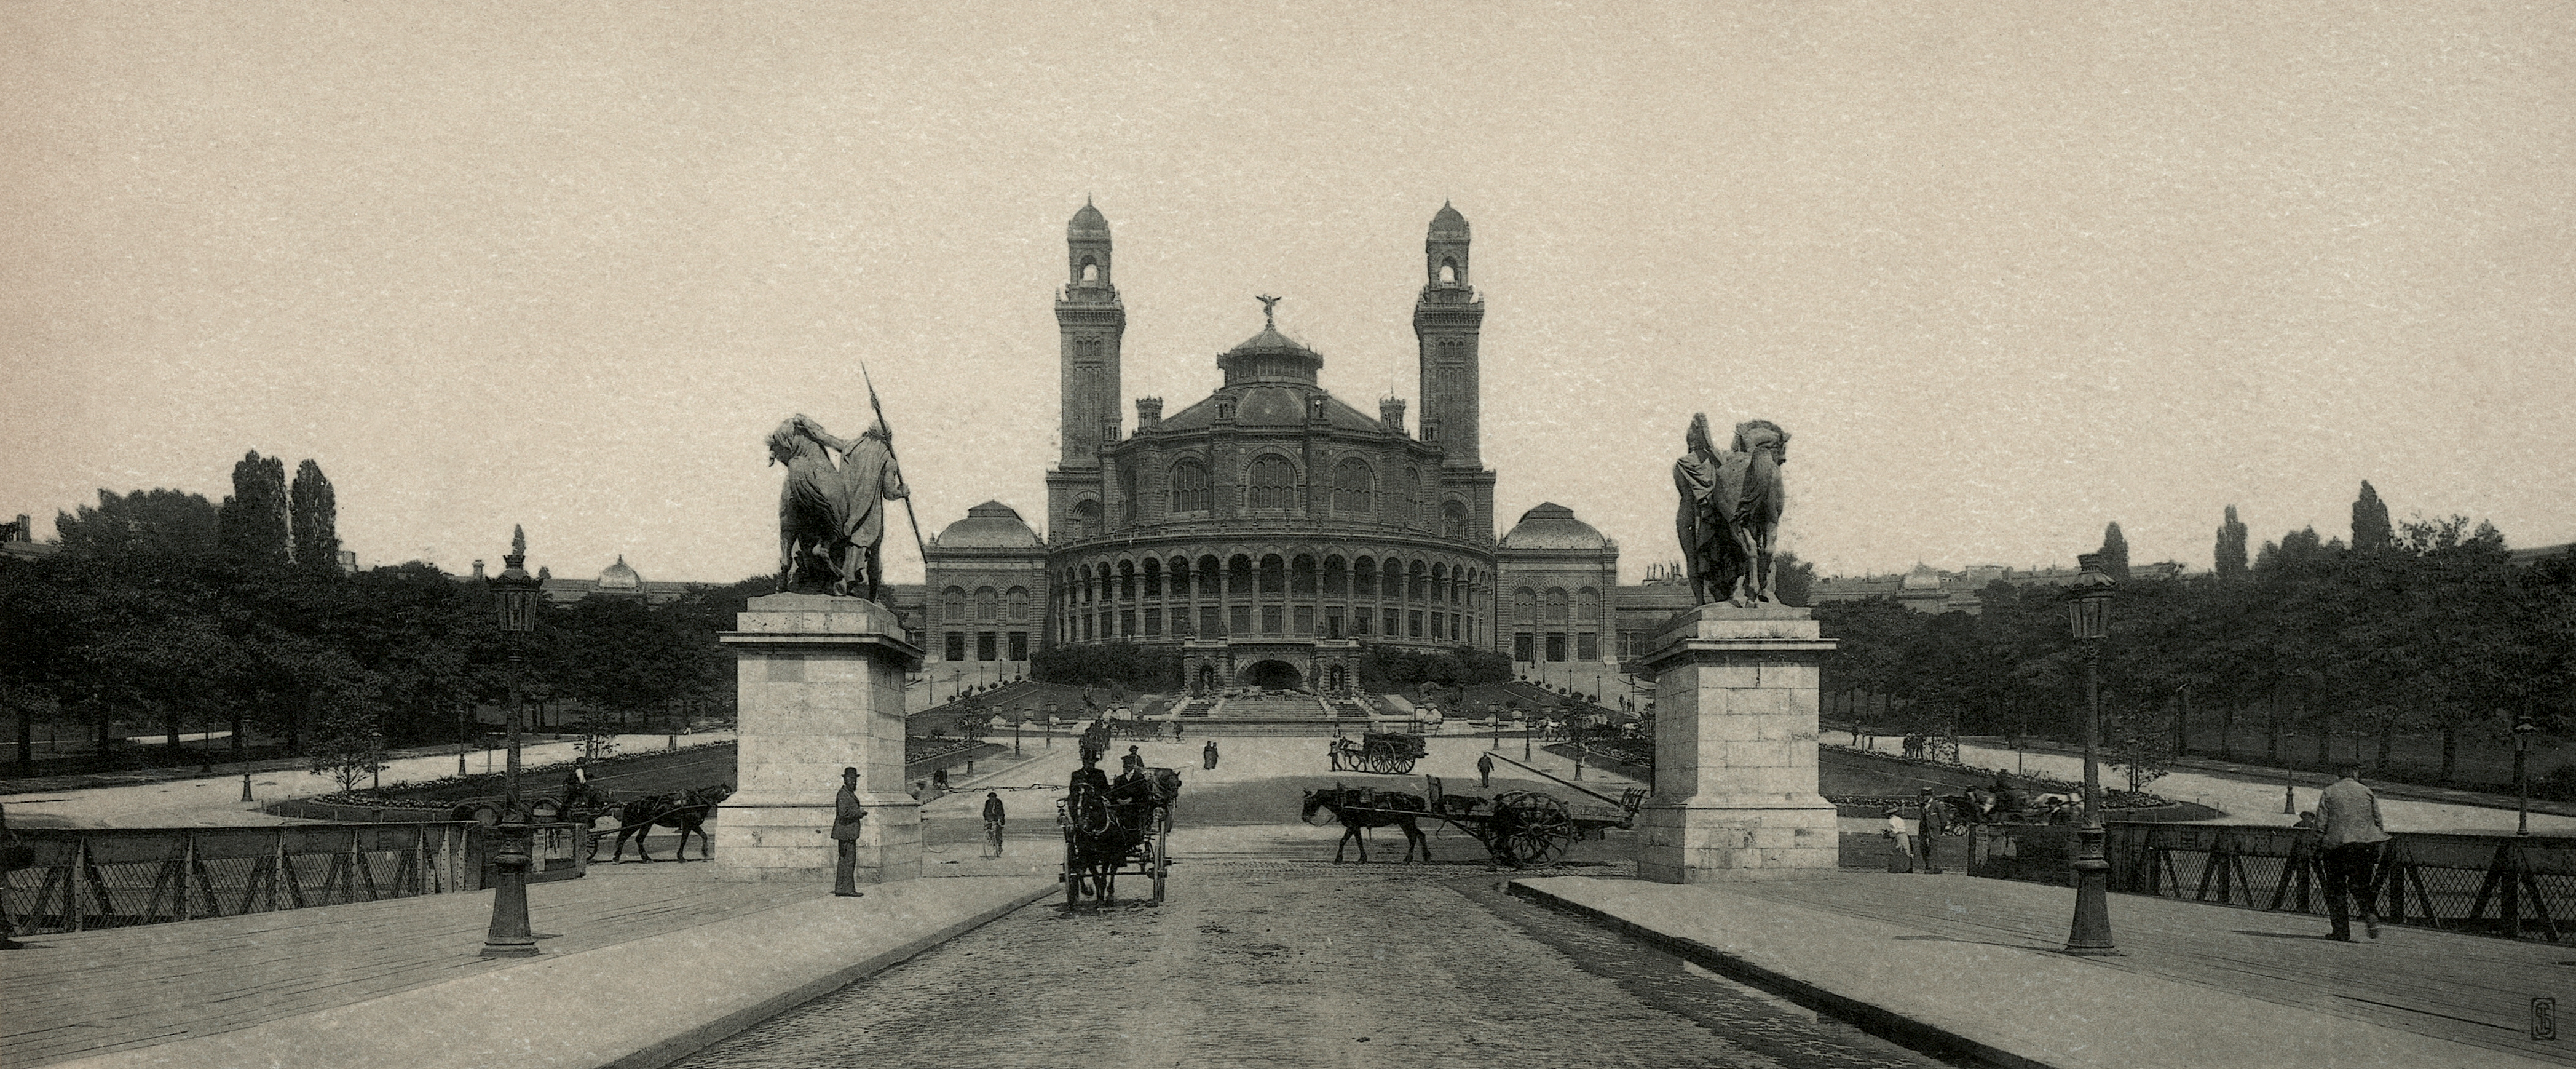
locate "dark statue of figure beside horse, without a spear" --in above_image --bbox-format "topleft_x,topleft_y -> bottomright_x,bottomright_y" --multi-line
1672,412 -> 1788,608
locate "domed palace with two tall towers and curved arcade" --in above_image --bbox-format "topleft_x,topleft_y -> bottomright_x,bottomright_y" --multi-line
922,204 -> 1618,690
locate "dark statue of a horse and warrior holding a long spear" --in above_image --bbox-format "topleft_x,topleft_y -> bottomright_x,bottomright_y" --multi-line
770,415 -> 909,600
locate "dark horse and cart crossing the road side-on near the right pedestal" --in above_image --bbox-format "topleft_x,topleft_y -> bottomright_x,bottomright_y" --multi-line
1301,776 -> 1646,868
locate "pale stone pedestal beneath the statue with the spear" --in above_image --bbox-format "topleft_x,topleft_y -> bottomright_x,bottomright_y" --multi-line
716,595 -> 922,886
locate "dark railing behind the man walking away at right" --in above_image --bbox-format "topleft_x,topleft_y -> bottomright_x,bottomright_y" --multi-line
1968,822 -> 2576,943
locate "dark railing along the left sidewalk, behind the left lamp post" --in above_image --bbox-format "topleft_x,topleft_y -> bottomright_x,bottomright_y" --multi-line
0,822 -> 585,935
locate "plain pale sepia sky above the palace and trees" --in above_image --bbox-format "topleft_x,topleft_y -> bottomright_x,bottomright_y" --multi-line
0,0 -> 2576,579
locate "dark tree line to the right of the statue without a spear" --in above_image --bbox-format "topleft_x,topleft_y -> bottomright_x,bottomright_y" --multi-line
1816,482 -> 2576,783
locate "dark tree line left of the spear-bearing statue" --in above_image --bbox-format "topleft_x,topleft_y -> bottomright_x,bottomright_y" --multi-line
0,453 -> 770,768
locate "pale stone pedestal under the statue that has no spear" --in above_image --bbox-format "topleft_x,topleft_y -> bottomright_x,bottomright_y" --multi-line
1636,603 -> 1842,883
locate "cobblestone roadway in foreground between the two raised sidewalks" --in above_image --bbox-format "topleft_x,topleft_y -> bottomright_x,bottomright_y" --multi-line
685,860 -> 1937,1069
